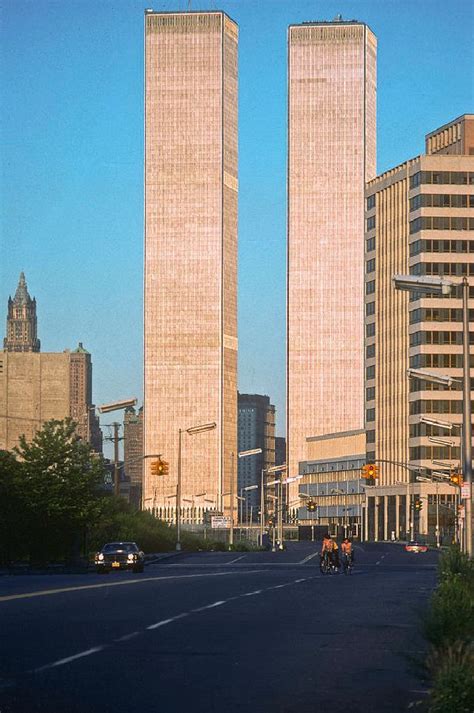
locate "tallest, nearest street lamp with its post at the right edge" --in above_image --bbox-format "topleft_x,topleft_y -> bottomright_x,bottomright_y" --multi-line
393,275 -> 472,557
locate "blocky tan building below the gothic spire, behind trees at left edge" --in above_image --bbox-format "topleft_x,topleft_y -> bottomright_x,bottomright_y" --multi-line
0,344 -> 102,452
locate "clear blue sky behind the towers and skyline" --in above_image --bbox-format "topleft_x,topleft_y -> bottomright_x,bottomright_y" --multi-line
0,0 -> 474,435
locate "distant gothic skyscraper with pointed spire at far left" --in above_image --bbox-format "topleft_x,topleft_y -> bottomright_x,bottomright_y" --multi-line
3,272 -> 40,352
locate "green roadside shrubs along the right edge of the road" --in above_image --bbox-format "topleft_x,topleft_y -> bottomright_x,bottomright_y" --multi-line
423,547 -> 474,713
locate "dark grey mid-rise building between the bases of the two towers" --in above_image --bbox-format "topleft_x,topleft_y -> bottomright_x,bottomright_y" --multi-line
238,394 -> 275,522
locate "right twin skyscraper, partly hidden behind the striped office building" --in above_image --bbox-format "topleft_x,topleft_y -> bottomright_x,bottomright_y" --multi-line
287,20 -> 377,499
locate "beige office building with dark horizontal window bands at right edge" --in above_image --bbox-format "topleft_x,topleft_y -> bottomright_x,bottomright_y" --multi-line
365,115 -> 474,539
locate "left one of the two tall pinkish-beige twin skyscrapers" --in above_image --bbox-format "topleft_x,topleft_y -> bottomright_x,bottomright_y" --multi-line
144,11 -> 238,519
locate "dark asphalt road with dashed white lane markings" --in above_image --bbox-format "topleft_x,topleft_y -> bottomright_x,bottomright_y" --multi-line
0,543 -> 437,713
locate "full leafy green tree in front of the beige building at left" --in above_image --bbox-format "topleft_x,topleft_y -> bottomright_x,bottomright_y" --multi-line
15,419 -> 105,561
